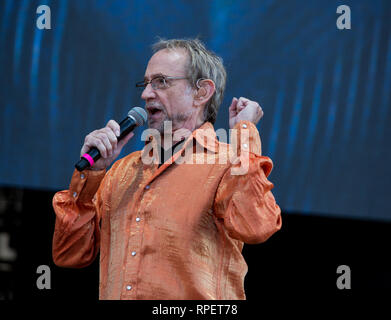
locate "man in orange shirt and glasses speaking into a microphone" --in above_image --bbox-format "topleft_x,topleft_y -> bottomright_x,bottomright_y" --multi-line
53,40 -> 281,299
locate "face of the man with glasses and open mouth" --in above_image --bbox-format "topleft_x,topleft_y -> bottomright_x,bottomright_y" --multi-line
141,49 -> 195,133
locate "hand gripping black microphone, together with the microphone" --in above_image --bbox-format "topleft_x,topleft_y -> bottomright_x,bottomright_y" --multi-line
75,107 -> 147,171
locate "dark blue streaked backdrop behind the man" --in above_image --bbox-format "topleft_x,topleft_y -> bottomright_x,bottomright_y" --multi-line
0,0 -> 391,220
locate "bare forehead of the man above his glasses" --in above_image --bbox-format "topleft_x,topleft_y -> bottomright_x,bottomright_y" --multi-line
145,49 -> 187,78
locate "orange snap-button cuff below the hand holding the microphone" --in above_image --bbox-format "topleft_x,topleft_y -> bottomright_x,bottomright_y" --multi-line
69,169 -> 106,201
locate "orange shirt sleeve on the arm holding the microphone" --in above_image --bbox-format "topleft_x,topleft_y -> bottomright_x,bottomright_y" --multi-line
52,170 -> 106,268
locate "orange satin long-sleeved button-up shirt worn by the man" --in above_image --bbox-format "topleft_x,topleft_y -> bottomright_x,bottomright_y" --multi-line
53,121 -> 281,300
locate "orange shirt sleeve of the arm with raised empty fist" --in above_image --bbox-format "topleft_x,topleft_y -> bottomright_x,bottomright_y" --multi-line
214,121 -> 282,244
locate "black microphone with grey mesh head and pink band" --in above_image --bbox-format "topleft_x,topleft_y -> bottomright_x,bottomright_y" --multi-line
75,107 -> 148,171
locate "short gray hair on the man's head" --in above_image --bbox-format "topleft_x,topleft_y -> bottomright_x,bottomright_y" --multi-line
152,39 -> 227,124
